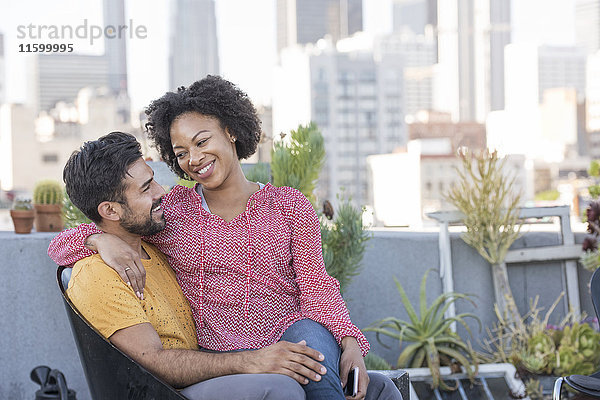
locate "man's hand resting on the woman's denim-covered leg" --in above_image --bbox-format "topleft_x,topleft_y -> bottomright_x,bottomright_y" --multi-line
246,340 -> 327,384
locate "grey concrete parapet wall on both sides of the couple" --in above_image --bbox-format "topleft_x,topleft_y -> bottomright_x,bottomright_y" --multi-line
0,231 -> 594,400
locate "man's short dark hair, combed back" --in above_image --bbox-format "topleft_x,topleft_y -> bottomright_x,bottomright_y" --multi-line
63,132 -> 142,223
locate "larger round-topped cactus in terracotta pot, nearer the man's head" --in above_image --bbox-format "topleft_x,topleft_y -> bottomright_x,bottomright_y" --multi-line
33,180 -> 64,232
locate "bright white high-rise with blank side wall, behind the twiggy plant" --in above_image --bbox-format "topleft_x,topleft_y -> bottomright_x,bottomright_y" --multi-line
486,43 -> 586,162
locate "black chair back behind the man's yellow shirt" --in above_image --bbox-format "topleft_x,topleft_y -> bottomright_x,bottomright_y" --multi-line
56,267 -> 186,400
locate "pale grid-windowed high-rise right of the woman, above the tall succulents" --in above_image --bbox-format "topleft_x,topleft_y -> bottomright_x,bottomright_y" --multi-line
310,38 -> 406,204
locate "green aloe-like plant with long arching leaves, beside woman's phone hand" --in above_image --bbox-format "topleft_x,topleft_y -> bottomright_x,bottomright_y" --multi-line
365,270 -> 481,390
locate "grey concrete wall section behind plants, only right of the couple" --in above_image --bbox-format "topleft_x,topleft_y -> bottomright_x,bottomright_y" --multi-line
344,231 -> 595,365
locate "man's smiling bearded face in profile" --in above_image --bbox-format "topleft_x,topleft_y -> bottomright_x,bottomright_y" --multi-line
121,158 -> 166,236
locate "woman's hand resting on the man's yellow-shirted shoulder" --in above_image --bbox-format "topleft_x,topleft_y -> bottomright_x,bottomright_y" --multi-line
85,233 -> 146,300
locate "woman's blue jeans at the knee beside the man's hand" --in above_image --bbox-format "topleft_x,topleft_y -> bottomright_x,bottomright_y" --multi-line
279,319 -> 345,400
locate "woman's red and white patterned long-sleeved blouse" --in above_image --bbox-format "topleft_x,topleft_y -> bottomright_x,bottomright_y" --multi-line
48,184 -> 369,355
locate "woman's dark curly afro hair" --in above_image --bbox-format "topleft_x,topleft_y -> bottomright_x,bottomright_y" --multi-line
146,75 -> 261,178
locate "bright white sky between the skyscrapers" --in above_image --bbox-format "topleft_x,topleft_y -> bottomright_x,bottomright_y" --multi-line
0,0 -> 575,110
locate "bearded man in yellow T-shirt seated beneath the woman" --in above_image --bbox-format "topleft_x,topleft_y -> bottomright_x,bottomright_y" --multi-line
63,132 -> 323,399
